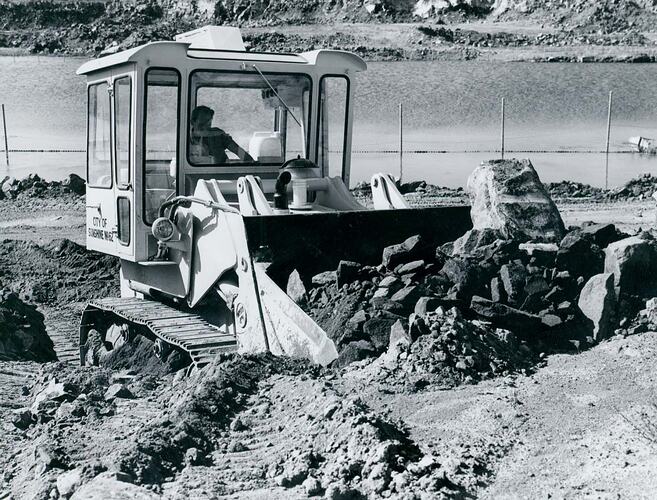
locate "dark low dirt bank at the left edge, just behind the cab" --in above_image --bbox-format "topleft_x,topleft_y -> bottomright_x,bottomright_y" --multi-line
0,239 -> 119,305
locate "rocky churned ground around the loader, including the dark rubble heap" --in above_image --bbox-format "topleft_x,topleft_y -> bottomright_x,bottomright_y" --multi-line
5,170 -> 657,499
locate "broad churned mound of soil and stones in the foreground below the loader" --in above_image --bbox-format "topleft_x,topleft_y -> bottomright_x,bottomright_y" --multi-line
8,355 -> 476,498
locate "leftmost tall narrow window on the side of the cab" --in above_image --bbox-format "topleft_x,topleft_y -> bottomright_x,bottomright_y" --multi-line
87,82 -> 112,188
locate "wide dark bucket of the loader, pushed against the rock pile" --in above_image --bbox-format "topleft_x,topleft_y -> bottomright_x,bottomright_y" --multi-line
244,206 -> 472,289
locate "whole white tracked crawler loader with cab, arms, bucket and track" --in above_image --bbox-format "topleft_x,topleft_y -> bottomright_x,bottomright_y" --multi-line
78,26 -> 470,367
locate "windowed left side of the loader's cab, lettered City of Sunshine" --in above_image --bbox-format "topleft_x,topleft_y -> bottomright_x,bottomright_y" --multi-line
87,75 -> 134,259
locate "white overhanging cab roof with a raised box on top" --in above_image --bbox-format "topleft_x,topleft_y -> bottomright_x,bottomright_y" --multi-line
77,26 -> 367,75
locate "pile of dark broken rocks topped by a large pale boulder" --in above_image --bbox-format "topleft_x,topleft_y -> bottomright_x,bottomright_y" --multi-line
307,161 -> 657,381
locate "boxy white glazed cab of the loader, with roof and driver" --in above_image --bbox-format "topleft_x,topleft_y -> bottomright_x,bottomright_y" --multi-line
78,26 -> 366,262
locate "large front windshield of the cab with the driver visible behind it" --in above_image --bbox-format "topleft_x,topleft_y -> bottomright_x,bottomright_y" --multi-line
187,68 -> 311,166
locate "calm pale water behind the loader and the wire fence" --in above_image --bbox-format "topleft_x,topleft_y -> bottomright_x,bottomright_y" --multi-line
0,56 -> 657,186
